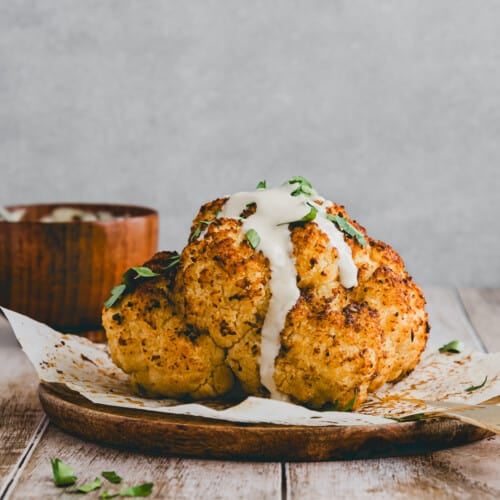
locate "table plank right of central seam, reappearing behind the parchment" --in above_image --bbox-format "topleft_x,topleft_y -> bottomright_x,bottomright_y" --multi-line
286,287 -> 500,500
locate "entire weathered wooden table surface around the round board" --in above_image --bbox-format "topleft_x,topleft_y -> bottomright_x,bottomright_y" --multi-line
0,287 -> 500,500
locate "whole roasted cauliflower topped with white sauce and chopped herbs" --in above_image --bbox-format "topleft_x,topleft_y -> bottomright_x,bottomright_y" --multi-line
103,177 -> 429,410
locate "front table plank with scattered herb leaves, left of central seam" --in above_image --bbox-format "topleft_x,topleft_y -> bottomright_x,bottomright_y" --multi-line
10,425 -> 281,500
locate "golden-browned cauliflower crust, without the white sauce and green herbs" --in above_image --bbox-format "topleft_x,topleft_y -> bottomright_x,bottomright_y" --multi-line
103,191 -> 429,409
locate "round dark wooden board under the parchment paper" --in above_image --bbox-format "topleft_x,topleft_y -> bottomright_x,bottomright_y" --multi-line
39,385 -> 491,461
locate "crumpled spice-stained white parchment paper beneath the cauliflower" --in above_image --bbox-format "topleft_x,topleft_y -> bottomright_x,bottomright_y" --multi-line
0,308 -> 500,433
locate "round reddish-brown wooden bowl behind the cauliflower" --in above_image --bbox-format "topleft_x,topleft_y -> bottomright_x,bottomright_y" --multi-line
0,203 -> 158,332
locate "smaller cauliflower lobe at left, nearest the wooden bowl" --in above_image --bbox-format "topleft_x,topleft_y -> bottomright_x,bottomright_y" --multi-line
103,252 -> 234,399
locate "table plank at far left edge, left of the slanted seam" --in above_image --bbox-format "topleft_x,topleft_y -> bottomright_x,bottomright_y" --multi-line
0,314 -> 46,498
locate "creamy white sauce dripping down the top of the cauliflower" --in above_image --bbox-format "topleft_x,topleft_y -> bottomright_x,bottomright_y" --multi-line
219,183 -> 357,400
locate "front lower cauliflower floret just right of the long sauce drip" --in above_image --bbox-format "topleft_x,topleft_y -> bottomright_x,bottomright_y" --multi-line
275,297 -> 383,409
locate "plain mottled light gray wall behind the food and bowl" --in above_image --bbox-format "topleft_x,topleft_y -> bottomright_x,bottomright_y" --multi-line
0,0 -> 500,286
